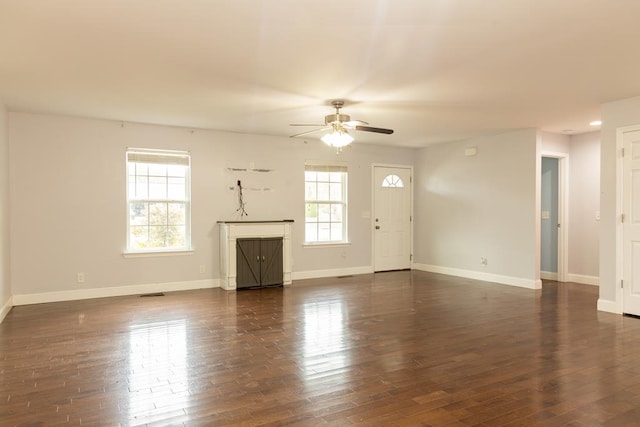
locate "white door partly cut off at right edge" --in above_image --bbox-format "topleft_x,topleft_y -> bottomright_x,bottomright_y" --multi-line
622,131 -> 640,315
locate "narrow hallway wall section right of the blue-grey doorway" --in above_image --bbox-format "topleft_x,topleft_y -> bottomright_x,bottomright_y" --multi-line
568,131 -> 600,283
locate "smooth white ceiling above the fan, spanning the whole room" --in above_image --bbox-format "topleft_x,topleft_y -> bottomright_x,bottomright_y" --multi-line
0,0 -> 640,146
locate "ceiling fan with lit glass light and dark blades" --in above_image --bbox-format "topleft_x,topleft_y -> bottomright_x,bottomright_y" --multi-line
291,100 -> 393,151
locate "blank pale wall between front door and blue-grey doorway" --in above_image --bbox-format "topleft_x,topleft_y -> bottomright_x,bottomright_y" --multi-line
414,129 -> 539,287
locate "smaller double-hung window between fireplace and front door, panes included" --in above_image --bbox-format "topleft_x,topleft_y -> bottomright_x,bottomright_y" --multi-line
304,162 -> 348,243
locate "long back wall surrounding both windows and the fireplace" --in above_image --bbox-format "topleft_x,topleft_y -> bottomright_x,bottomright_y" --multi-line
9,113 -> 415,304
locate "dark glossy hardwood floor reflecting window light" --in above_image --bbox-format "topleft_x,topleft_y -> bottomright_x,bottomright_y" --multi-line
0,271 -> 640,426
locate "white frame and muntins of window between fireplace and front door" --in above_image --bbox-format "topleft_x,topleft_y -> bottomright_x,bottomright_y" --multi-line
304,161 -> 349,246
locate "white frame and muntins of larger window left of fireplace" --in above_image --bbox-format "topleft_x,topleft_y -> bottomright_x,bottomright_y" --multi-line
125,148 -> 192,254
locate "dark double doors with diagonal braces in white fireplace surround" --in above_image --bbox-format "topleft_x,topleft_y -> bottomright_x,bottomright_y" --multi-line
236,237 -> 284,289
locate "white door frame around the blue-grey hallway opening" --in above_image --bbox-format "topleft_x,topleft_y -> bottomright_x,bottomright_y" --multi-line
536,151 -> 569,282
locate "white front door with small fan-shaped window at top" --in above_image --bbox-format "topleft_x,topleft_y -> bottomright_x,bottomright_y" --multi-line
373,166 -> 412,271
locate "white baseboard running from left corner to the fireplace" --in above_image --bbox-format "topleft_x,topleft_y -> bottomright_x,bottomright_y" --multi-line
13,279 -> 220,305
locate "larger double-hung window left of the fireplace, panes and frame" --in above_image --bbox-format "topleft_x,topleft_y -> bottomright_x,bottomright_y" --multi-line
127,149 -> 191,252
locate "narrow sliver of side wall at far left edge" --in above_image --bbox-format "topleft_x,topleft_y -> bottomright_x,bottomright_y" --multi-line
0,102 -> 11,321
